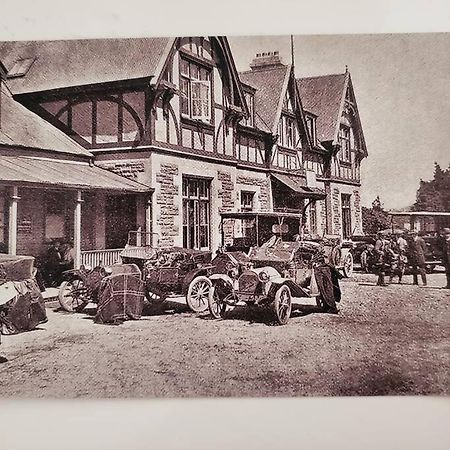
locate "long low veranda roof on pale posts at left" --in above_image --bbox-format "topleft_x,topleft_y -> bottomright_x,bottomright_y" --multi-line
0,156 -> 152,193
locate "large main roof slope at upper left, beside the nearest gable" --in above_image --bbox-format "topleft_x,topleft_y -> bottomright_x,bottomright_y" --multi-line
0,38 -> 174,95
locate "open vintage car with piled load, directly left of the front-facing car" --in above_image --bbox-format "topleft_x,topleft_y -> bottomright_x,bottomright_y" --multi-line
121,231 -> 213,312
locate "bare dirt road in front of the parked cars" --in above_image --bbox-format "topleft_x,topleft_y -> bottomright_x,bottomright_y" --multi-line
0,274 -> 450,398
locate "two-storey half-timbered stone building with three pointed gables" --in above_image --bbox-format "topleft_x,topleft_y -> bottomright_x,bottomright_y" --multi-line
0,36 -> 365,264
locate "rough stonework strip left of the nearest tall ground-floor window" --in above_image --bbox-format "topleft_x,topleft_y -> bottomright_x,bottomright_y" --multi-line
155,164 -> 181,246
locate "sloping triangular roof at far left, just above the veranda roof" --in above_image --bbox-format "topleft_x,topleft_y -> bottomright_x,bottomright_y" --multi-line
0,83 -> 92,157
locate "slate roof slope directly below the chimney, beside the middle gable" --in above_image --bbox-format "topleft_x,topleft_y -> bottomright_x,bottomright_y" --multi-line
239,65 -> 291,133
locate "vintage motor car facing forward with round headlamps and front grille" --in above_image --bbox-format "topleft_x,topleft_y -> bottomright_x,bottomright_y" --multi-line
208,217 -> 340,325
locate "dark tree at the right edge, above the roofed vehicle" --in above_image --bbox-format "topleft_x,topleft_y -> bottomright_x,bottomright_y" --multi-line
413,163 -> 450,211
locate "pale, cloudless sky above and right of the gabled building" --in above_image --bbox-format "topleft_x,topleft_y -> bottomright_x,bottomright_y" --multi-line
229,33 -> 450,209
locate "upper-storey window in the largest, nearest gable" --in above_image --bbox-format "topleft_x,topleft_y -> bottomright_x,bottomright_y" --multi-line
180,58 -> 211,122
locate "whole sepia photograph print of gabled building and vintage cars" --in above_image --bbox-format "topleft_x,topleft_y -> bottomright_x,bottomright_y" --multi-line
0,29 -> 450,399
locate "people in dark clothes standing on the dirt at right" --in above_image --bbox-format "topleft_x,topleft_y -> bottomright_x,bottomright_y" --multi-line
368,228 -> 450,289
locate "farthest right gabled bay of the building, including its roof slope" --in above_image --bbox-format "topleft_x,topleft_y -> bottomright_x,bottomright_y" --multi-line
297,70 -> 367,238
